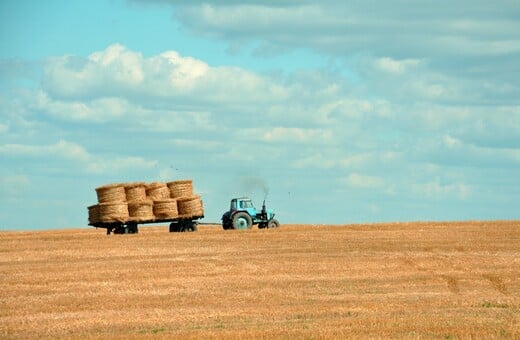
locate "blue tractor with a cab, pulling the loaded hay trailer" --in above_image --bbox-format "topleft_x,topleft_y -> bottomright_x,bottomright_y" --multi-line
222,197 -> 280,230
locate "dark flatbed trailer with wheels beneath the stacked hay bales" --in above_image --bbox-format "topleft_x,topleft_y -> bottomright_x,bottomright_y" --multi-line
89,215 -> 204,235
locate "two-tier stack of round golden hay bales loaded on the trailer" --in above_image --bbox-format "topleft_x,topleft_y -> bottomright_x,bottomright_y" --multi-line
88,180 -> 204,225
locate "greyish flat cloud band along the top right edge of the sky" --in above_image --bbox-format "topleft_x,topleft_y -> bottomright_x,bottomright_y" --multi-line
168,0 -> 520,63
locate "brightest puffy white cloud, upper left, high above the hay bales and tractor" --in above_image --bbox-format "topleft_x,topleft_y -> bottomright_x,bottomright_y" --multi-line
43,45 -> 286,106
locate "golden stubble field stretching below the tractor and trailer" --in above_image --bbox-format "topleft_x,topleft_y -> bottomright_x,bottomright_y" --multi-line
0,221 -> 520,339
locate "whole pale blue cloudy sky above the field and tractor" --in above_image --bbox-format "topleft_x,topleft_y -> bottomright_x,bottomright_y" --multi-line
0,0 -> 520,230
